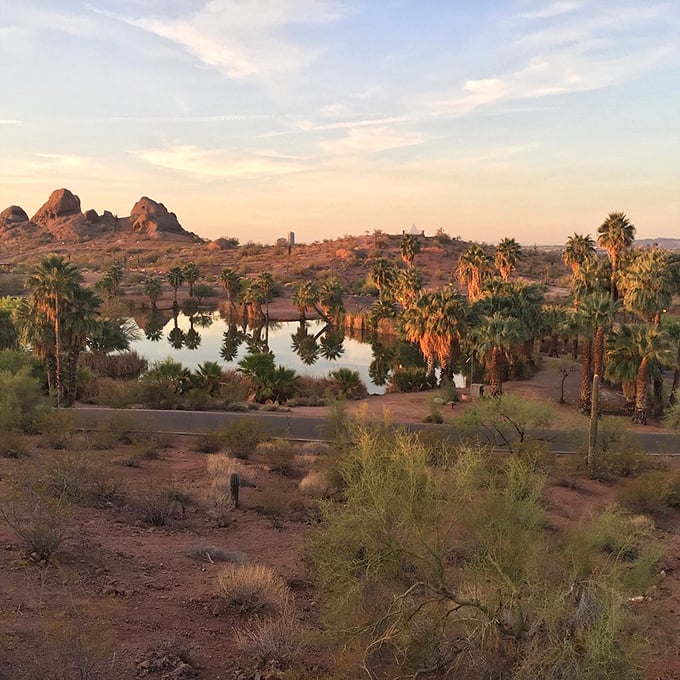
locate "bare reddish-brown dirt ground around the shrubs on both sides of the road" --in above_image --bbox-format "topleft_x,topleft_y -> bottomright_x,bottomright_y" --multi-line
0,362 -> 680,680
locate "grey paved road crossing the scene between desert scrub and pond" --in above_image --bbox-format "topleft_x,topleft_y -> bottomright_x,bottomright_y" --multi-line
74,407 -> 680,455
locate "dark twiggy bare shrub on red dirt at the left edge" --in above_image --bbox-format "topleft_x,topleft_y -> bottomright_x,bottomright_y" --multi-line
0,486 -> 71,562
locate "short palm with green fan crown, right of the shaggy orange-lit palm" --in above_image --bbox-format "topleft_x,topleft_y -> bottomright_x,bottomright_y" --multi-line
474,312 -> 524,397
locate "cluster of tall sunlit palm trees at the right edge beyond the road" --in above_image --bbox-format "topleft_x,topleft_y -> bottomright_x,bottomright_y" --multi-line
564,212 -> 680,424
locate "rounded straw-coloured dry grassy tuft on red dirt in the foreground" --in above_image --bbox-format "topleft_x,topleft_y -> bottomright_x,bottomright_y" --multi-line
217,564 -> 291,614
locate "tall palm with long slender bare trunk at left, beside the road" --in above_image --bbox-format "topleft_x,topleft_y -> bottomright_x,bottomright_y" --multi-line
27,255 -> 83,406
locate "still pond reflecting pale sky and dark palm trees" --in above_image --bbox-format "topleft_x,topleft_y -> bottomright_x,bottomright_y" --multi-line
131,312 -> 398,394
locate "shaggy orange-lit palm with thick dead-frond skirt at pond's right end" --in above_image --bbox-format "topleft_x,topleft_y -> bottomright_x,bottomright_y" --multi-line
402,288 -> 468,378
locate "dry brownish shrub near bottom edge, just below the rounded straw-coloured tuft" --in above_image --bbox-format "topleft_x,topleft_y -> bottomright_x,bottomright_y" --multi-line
236,612 -> 301,668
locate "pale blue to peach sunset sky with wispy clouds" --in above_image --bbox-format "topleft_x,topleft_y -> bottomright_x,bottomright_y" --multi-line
0,0 -> 680,245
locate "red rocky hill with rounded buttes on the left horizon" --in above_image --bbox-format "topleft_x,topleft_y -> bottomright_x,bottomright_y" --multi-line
0,189 -> 201,244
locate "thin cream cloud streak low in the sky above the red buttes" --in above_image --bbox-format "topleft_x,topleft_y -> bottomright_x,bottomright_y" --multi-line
130,144 -> 304,179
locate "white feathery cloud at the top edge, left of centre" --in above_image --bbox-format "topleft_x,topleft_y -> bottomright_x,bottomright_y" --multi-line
112,0 -> 344,78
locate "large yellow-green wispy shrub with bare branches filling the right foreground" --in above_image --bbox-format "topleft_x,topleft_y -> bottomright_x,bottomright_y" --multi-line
306,430 -> 660,680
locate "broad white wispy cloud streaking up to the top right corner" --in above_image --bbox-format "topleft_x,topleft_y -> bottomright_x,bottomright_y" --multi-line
440,1 -> 680,115
